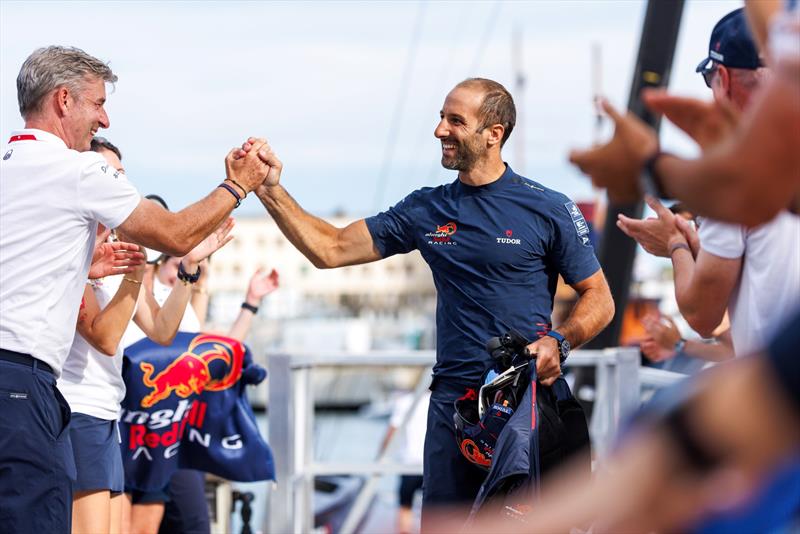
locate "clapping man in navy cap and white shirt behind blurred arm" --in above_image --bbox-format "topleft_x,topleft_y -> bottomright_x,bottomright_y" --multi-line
618,9 -> 800,356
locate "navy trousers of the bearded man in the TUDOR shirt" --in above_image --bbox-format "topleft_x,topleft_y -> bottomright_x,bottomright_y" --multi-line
422,381 -> 486,532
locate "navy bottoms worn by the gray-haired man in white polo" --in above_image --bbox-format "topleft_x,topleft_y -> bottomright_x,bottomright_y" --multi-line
0,349 -> 75,534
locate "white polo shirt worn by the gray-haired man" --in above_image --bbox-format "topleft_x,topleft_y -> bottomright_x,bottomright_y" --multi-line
0,129 -> 141,376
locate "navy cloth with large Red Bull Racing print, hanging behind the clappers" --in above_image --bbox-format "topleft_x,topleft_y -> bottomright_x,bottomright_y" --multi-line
120,332 -> 275,491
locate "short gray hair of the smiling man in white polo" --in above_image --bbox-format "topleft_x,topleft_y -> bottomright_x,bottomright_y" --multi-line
17,46 -> 117,119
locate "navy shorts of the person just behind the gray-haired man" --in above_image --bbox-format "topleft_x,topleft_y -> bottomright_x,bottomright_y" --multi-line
69,412 -> 125,493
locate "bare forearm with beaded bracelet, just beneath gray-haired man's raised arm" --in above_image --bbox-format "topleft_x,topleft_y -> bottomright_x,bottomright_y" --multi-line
79,273 -> 141,356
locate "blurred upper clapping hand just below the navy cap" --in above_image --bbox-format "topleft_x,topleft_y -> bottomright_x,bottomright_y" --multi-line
642,89 -> 740,150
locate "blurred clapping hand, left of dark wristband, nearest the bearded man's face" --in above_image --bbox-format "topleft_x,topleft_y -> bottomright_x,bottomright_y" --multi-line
569,100 -> 658,204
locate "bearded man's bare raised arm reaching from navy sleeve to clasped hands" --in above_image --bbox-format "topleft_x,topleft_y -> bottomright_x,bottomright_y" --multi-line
250,140 -> 381,269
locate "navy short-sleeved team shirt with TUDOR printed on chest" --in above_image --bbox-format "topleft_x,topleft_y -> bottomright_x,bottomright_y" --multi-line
366,165 -> 600,384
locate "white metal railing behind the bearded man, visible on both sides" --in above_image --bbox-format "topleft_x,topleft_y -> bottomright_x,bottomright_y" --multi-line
264,348 -> 685,534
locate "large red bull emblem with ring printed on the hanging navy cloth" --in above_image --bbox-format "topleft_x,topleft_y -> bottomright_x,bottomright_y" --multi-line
139,334 -> 244,408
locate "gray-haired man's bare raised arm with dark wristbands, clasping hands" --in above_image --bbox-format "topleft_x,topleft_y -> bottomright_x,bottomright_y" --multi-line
120,140 -> 267,256
